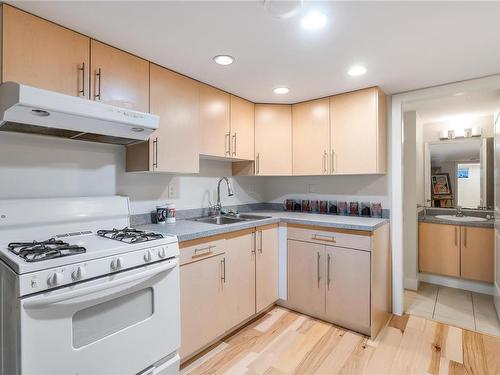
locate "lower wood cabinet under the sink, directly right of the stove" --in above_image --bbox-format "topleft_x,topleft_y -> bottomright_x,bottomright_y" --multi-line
179,225 -> 278,361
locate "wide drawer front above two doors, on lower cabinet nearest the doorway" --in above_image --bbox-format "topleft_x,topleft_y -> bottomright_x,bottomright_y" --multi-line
287,225 -> 371,251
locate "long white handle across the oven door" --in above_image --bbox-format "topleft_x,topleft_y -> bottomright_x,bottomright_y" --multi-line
23,259 -> 179,309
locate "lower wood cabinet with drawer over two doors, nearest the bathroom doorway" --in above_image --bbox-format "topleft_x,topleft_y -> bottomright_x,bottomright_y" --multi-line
279,224 -> 391,337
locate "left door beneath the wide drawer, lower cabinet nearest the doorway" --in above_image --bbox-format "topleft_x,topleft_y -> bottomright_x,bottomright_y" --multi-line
287,240 -> 326,316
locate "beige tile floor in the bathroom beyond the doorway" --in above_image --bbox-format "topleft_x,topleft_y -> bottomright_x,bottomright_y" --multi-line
405,283 -> 500,336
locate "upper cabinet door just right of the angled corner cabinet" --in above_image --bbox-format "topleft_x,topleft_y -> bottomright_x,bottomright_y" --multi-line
292,98 -> 330,175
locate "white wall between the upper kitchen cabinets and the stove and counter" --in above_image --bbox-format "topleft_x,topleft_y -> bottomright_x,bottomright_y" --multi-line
0,133 -> 389,214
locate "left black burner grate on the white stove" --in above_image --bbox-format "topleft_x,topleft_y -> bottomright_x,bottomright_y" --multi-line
7,238 -> 86,263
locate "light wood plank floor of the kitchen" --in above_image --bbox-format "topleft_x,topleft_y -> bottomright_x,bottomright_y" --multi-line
181,307 -> 500,375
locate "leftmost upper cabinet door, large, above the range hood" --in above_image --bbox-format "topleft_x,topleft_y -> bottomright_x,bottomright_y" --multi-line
2,4 -> 90,98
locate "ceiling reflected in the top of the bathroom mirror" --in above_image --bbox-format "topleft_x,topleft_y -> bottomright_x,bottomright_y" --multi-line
429,139 -> 481,162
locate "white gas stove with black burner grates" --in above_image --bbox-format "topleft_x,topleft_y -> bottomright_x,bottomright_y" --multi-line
0,197 -> 180,375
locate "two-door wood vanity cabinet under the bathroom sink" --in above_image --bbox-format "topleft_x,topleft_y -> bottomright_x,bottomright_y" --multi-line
418,223 -> 495,283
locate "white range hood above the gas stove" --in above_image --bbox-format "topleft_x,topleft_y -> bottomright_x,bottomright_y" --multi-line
0,82 -> 160,145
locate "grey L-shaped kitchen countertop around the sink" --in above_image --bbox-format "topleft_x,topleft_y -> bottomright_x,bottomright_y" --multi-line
135,211 -> 389,241
